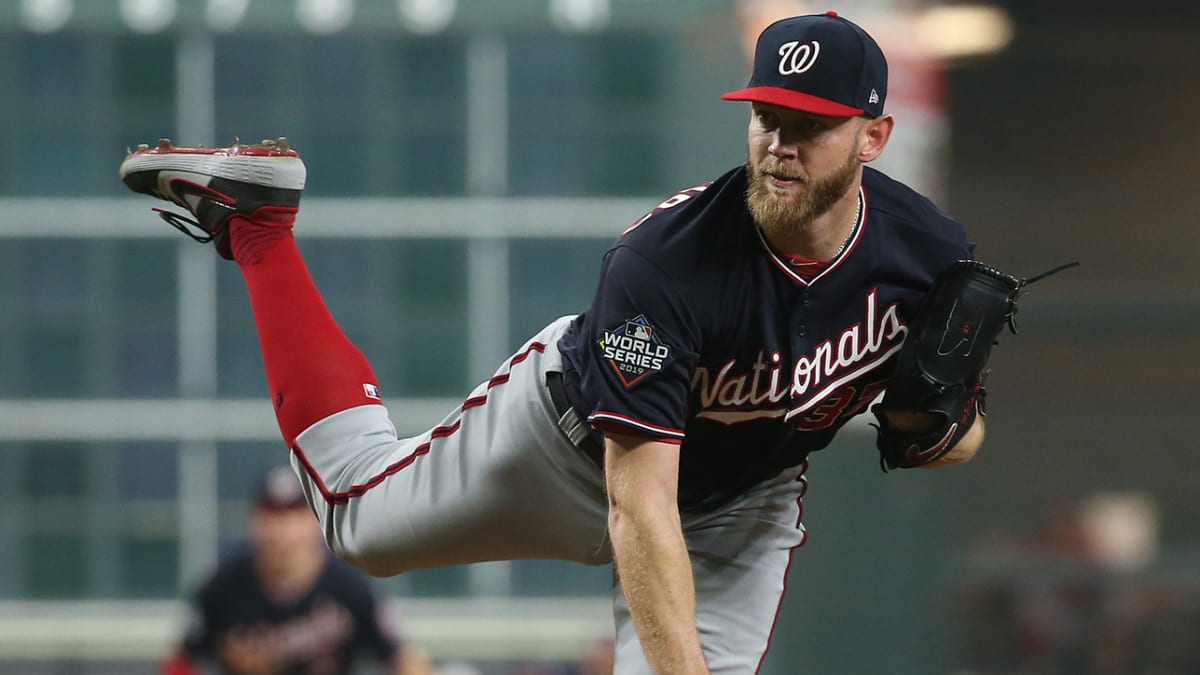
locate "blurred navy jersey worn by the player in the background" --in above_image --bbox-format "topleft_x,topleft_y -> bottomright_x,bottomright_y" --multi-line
182,552 -> 398,675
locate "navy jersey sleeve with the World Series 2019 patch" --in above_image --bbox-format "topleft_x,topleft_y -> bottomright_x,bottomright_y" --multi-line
575,246 -> 701,444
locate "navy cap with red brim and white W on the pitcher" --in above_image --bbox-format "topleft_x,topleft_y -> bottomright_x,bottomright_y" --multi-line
721,12 -> 888,118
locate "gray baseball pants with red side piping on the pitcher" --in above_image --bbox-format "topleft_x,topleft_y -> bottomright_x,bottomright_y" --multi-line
284,317 -> 805,675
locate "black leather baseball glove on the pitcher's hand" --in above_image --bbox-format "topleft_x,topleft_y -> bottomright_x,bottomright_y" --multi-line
871,261 -> 1079,471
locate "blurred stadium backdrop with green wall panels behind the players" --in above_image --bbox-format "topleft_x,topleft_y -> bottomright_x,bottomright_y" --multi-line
0,0 -> 1200,674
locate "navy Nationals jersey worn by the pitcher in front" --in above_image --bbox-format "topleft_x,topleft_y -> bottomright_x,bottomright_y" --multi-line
559,167 -> 972,509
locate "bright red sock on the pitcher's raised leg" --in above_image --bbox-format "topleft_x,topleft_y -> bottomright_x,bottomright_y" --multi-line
229,214 -> 382,448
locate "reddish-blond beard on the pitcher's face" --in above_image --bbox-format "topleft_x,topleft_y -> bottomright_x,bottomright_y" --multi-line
746,155 -> 859,238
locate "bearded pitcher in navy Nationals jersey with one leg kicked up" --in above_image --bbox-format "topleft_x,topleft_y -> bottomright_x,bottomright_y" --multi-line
120,12 -> 1070,675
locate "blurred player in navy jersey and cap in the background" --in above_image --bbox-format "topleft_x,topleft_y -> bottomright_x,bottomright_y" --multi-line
162,466 -> 432,675
